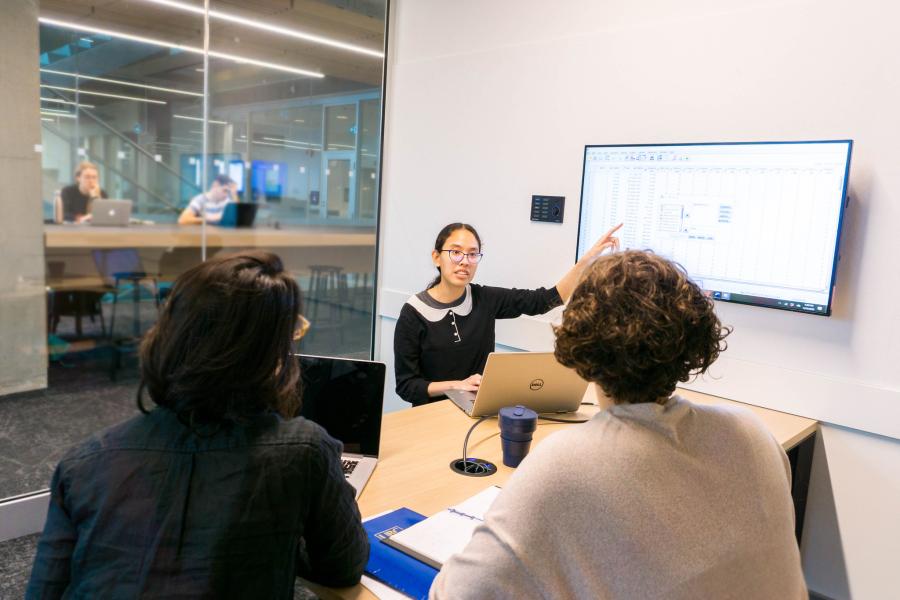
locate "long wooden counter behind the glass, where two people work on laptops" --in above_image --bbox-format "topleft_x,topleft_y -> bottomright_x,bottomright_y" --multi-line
44,224 -> 375,248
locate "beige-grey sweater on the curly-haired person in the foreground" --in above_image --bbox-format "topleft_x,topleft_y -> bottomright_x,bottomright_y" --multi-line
431,396 -> 808,600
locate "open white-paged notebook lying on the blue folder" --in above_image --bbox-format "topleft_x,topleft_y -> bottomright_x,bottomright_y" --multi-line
381,485 -> 500,569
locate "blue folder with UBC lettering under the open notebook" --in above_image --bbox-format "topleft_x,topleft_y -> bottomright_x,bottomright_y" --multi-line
363,508 -> 438,600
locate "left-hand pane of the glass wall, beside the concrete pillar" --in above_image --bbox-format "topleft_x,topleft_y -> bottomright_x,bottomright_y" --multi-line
21,0 -> 204,502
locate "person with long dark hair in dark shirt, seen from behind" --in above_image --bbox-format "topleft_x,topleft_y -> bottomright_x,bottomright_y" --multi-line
26,251 -> 368,599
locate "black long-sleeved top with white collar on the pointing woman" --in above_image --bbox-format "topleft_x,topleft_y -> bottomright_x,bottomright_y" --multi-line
394,284 -> 562,406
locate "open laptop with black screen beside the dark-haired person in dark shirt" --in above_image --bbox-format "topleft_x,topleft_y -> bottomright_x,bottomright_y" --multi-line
297,354 -> 385,498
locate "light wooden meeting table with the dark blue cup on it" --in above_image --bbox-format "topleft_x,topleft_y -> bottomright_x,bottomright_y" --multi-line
310,389 -> 818,599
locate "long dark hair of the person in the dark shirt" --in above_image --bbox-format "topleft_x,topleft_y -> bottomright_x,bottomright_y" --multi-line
138,251 -> 301,425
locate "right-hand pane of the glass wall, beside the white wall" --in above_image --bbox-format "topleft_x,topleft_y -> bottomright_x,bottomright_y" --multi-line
209,2 -> 384,357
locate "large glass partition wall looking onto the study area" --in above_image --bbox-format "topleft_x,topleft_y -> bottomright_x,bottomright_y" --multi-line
0,0 -> 387,506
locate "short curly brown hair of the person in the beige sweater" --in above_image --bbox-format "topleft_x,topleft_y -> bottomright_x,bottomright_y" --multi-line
554,250 -> 731,404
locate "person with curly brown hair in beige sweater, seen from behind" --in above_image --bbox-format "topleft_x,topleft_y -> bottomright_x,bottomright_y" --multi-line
431,251 -> 808,600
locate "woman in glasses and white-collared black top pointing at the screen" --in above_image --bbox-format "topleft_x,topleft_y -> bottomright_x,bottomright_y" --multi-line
394,223 -> 622,406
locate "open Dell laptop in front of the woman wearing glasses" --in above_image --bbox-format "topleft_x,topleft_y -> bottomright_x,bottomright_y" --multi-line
447,352 -> 587,417
